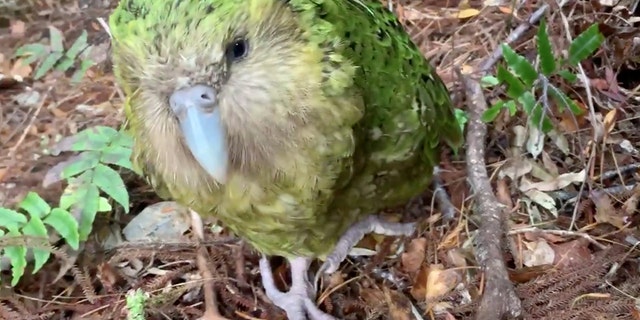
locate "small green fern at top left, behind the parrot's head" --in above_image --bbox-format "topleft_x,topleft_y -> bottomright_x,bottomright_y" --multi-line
15,26 -> 94,83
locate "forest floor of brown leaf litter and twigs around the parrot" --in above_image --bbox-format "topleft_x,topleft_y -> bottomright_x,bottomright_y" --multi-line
0,0 -> 640,319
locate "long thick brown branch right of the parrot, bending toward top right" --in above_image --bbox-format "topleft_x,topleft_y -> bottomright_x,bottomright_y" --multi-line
457,4 -> 549,320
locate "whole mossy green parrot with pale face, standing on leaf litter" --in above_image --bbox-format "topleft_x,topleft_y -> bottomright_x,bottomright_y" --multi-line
109,0 -> 463,320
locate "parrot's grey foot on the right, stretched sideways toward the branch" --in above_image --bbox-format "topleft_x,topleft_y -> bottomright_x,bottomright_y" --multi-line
315,215 -> 416,276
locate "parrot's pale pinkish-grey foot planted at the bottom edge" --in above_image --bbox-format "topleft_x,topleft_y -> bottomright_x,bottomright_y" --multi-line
260,255 -> 336,320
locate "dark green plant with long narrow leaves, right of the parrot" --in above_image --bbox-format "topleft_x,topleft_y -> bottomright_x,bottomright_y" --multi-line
482,19 -> 604,133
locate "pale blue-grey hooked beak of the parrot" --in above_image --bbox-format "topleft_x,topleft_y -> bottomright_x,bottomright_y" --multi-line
169,85 -> 229,184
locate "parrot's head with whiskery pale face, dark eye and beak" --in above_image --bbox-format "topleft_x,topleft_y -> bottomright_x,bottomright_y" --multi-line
110,0 -> 344,185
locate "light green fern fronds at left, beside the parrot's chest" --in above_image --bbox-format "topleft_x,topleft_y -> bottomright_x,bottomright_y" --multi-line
0,126 -> 133,286
